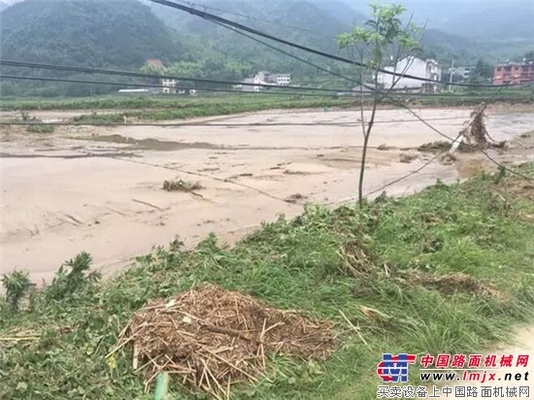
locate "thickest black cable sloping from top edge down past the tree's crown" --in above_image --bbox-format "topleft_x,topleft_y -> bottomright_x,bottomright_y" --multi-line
150,0 -> 512,89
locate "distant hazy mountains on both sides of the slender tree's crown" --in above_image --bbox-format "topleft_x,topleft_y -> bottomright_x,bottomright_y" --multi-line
150,0 -> 534,69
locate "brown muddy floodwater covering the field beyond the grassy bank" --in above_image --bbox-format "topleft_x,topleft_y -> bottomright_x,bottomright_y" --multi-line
0,105 -> 534,282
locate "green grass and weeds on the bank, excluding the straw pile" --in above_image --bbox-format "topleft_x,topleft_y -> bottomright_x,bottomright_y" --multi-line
0,165 -> 534,400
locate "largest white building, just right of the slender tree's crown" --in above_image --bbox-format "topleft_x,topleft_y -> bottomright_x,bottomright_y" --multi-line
377,57 -> 441,93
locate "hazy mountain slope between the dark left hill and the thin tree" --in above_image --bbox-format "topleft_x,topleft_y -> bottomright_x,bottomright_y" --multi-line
144,0 -> 356,74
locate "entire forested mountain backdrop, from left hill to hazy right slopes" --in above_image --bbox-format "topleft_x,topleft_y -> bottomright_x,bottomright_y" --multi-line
0,0 -> 534,96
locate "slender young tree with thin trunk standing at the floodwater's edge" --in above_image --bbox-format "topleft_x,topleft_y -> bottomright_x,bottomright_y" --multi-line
337,3 -> 420,207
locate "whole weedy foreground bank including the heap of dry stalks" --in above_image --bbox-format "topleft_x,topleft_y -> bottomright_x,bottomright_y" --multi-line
0,165 -> 534,400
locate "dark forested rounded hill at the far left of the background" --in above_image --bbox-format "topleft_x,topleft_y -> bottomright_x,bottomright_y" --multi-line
0,0 -> 188,69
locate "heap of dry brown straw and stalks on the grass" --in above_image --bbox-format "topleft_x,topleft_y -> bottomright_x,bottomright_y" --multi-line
116,286 -> 334,399
